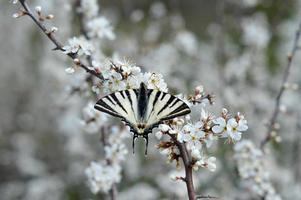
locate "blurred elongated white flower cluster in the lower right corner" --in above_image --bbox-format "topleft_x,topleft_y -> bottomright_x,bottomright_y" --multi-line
234,140 -> 281,200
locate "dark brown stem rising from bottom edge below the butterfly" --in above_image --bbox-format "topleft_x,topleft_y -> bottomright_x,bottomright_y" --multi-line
168,134 -> 196,200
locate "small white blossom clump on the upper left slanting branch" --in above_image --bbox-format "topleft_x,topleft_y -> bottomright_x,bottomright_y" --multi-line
63,36 -> 94,56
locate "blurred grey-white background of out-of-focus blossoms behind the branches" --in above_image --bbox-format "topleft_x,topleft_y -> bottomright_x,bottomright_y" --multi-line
0,0 -> 301,200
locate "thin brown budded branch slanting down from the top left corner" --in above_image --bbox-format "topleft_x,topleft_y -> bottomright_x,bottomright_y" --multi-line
19,0 -> 103,80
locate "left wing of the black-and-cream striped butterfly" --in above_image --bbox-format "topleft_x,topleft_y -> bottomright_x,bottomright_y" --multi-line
94,89 -> 138,131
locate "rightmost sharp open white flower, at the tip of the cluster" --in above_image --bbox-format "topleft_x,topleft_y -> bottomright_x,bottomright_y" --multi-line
227,118 -> 248,141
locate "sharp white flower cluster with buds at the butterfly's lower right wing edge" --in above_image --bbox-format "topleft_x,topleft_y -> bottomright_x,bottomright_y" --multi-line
156,87 -> 248,171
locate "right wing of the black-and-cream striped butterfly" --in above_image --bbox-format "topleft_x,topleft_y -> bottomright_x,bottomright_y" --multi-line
145,90 -> 191,132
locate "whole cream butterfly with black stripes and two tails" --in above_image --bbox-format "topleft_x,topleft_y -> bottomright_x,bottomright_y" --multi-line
94,82 -> 191,155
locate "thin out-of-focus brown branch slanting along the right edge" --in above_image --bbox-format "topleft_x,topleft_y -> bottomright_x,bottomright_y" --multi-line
260,22 -> 301,149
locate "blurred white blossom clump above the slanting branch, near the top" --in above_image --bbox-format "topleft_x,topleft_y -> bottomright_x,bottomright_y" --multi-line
87,17 -> 115,40
